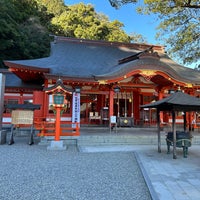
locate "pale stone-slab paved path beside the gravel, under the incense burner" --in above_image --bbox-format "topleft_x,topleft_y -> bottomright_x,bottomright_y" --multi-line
82,145 -> 200,200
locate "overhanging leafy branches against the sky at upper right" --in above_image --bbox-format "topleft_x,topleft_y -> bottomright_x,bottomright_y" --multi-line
109,0 -> 200,64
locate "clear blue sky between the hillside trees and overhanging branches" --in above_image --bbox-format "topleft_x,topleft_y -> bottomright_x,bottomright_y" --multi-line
65,0 -> 159,44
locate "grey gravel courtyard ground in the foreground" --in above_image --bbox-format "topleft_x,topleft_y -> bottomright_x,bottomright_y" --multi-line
0,138 -> 151,200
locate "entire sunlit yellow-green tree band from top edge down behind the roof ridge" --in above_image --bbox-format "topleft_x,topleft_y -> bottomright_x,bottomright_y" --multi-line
37,0 -> 144,42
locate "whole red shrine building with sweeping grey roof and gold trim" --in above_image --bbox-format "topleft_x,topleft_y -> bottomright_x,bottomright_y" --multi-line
0,36 -> 200,133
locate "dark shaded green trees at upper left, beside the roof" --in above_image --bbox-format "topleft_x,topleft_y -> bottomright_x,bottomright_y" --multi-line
0,0 -> 50,66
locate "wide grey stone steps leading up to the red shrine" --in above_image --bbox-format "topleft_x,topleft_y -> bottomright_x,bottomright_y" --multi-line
37,127 -> 200,146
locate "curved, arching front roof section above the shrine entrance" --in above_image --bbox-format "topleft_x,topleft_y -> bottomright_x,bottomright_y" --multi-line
95,55 -> 200,84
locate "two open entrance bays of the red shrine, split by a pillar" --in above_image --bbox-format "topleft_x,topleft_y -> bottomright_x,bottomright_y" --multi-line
80,92 -> 134,127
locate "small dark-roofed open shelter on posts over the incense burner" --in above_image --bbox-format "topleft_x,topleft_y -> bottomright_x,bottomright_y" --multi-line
141,91 -> 200,158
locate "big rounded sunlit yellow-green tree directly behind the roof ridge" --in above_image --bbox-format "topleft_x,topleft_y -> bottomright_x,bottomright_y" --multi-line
52,3 -> 130,42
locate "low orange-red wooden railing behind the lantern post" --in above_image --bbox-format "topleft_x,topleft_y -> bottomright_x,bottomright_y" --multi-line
34,119 -> 80,137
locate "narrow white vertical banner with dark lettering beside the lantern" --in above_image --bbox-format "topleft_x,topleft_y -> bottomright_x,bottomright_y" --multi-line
72,92 -> 80,128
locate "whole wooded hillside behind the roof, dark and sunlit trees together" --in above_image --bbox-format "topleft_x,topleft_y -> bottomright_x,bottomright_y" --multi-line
0,0 -> 147,66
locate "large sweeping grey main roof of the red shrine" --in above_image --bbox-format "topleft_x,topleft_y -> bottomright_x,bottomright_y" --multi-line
3,37 -> 200,84
